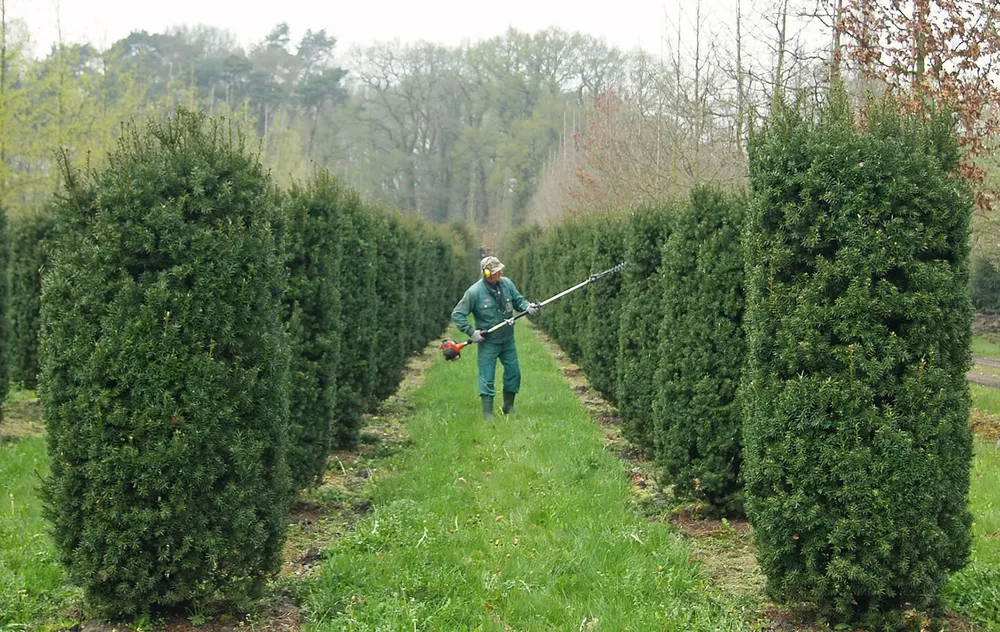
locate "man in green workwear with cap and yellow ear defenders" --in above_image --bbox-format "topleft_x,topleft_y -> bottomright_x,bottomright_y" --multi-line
451,257 -> 539,419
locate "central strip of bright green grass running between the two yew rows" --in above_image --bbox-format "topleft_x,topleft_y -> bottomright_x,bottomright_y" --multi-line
304,326 -> 743,632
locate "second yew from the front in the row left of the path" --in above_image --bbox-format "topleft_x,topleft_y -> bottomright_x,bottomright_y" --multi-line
283,171 -> 345,489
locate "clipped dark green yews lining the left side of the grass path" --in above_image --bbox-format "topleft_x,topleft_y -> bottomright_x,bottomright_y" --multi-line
0,111 -> 476,614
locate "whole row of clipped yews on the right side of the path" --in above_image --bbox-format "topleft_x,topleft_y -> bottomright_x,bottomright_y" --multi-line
505,90 -> 972,626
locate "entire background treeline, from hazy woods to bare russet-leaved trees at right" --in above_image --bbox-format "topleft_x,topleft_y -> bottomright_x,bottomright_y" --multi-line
0,0 -> 1000,259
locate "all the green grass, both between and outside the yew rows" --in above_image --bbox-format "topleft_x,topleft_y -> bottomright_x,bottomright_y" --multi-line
0,328 -> 1000,632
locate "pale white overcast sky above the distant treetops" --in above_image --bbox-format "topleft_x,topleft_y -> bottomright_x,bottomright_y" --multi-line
5,0 -> 688,59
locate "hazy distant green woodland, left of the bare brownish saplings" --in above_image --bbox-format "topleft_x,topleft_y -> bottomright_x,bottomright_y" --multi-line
0,21 -> 628,235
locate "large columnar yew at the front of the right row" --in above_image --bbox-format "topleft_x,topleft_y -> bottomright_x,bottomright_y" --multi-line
743,94 -> 972,626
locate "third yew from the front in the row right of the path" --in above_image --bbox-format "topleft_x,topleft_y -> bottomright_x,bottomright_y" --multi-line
617,205 -> 674,454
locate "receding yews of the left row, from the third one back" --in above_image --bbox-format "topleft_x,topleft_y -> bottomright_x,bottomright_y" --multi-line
334,205 -> 475,447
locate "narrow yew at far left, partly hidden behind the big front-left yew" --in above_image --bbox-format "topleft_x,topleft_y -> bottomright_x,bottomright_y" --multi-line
9,209 -> 55,388
